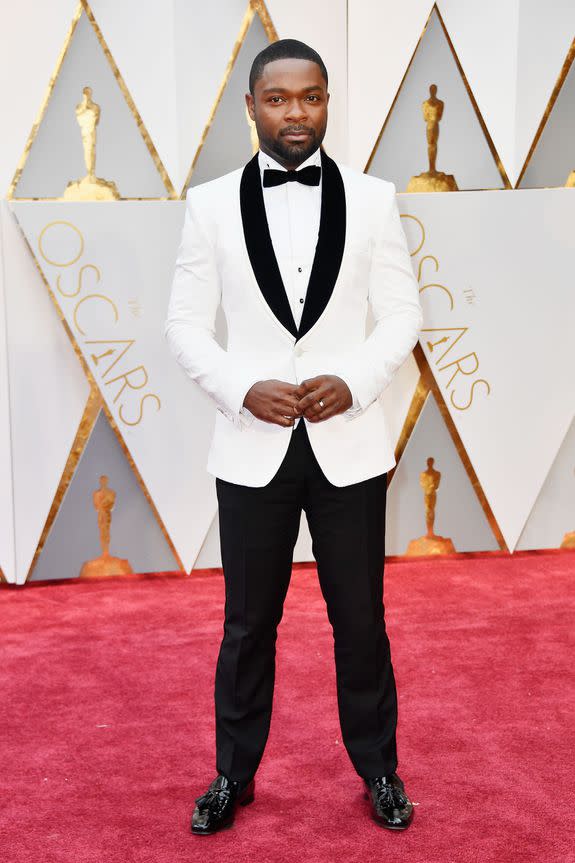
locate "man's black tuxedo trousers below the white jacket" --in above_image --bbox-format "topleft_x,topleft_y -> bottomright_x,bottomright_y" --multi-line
215,419 -> 397,782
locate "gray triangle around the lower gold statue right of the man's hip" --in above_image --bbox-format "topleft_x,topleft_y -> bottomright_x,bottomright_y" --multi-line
386,394 -> 499,555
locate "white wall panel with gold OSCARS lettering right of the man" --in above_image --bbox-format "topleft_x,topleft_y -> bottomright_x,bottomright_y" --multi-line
400,189 -> 575,549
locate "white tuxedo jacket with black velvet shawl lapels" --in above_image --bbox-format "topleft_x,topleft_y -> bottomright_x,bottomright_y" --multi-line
164,151 -> 422,486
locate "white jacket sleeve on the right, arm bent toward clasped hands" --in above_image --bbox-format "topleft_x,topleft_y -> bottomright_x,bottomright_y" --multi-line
334,183 -> 423,418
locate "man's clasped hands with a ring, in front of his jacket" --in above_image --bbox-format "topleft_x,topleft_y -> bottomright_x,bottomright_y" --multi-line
244,375 -> 353,426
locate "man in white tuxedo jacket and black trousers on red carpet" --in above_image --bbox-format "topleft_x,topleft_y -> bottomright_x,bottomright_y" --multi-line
165,39 -> 422,834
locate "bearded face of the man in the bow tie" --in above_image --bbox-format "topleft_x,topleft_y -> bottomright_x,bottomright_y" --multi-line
246,59 -> 329,168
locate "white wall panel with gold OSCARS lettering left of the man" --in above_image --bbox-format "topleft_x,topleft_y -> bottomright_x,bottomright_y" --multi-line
13,201 -> 220,570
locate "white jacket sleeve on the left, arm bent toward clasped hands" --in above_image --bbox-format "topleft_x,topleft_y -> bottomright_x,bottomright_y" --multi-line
164,189 -> 259,428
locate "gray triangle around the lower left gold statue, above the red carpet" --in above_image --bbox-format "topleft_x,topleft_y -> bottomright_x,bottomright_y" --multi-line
30,411 -> 180,581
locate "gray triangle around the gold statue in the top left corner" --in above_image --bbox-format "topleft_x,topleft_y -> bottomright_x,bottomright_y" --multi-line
14,12 -> 167,198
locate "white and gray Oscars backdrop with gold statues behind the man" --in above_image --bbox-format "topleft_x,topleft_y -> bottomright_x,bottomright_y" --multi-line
0,0 -> 575,584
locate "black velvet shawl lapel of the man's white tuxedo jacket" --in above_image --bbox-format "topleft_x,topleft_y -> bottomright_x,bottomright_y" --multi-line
240,150 -> 346,339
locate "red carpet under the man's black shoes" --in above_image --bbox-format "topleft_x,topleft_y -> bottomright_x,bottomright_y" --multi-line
0,553 -> 575,863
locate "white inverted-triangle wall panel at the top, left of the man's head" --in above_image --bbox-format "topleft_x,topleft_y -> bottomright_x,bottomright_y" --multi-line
92,0 -> 247,192
